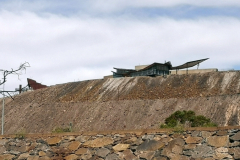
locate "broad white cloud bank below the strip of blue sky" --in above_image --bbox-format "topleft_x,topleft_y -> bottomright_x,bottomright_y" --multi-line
0,10 -> 240,92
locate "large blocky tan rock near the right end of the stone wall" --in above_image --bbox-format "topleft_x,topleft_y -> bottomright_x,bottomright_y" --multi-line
206,136 -> 229,147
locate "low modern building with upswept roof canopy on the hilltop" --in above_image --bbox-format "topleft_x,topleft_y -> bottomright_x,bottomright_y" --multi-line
112,58 -> 209,78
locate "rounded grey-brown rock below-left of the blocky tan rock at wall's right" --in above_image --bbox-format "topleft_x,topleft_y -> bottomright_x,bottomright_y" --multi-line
192,145 -> 214,158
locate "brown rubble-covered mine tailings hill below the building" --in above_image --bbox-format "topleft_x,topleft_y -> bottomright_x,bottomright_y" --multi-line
0,71 -> 240,134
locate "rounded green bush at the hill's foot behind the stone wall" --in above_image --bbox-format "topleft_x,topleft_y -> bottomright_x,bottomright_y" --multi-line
160,110 -> 217,128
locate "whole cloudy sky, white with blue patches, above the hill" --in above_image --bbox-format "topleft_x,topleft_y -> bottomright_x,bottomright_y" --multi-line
0,0 -> 240,90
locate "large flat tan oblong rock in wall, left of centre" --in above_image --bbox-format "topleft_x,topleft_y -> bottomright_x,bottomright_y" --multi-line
83,137 -> 113,148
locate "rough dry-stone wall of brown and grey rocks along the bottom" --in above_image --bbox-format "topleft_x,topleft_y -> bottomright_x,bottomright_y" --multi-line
0,127 -> 240,160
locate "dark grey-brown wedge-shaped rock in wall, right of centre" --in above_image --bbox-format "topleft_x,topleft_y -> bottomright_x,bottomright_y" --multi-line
137,140 -> 165,151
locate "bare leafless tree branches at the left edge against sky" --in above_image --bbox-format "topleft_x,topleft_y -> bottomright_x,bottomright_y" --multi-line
0,62 -> 30,97
